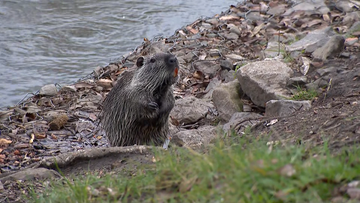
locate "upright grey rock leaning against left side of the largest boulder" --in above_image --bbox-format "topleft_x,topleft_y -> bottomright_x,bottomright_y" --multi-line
212,80 -> 243,121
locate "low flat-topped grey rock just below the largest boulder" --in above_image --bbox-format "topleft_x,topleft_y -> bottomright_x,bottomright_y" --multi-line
265,100 -> 311,116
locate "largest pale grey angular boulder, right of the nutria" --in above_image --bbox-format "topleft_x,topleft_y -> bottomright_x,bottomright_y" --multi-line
237,60 -> 293,107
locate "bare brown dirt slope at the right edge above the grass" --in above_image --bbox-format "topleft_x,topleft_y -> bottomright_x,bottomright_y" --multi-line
253,53 -> 360,150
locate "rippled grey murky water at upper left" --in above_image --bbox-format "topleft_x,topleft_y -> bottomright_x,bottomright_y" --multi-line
0,0 -> 239,107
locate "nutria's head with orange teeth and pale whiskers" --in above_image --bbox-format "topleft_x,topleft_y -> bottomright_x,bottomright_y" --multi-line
133,53 -> 179,89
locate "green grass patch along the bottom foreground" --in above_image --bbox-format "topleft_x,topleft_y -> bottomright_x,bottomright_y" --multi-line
31,135 -> 360,203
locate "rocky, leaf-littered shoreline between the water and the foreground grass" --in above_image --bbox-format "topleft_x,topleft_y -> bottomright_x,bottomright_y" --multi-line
0,0 -> 360,201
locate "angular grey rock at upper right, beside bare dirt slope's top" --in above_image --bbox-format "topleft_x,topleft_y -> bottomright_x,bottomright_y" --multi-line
312,35 -> 345,61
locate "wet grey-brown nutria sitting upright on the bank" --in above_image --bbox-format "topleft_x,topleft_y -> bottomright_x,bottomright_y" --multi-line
101,53 -> 179,146
